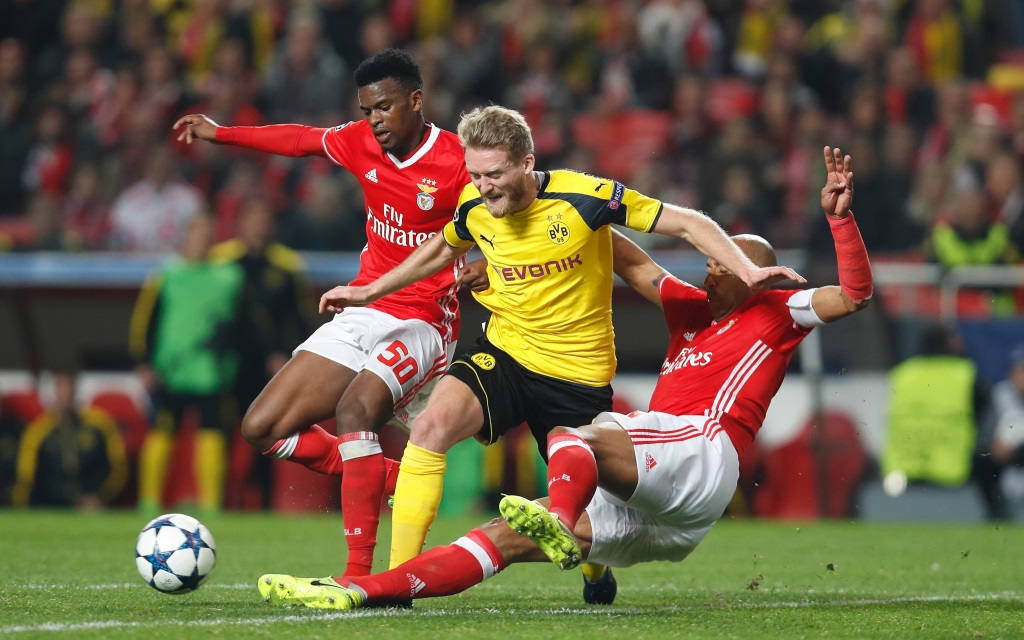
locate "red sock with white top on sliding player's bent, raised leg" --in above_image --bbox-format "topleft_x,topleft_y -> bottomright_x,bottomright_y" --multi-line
548,433 -> 597,530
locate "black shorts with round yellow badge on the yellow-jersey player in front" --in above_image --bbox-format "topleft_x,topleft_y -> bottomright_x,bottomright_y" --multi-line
445,337 -> 611,460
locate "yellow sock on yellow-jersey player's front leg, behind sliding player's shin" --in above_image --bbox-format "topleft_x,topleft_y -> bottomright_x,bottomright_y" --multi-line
390,442 -> 446,568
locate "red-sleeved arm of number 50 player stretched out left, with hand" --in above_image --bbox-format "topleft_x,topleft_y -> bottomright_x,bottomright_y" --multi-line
171,114 -> 327,158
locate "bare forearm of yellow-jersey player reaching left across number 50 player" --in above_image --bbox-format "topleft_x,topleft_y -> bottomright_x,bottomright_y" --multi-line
319,233 -> 473,313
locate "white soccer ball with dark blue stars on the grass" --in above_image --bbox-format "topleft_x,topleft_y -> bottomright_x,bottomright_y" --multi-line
135,513 -> 217,595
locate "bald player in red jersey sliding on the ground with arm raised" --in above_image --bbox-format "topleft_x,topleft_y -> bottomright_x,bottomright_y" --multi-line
260,146 -> 871,609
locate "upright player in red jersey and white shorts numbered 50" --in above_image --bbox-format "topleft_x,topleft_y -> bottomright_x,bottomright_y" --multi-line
174,49 -> 470,575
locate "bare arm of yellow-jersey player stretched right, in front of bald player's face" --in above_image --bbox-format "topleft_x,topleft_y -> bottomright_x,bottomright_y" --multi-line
651,203 -> 807,290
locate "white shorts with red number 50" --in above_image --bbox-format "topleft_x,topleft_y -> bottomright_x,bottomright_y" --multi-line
294,307 -> 455,411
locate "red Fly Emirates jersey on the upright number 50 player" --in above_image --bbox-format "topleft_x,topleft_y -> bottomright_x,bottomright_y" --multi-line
324,120 -> 470,341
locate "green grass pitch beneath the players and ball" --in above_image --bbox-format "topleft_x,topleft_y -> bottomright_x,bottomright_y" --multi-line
0,511 -> 1024,640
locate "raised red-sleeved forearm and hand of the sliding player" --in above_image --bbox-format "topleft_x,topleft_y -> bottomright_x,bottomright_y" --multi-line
811,146 -> 872,323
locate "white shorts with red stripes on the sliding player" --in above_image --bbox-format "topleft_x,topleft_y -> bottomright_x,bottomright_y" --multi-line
587,412 -> 739,566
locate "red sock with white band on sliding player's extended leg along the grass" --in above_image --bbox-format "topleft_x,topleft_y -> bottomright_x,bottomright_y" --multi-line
337,528 -> 505,602
